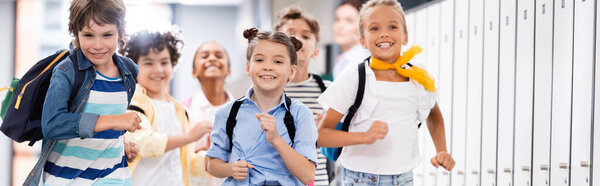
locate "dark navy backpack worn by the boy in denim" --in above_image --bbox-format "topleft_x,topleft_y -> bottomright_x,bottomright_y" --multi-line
0,50 -> 137,146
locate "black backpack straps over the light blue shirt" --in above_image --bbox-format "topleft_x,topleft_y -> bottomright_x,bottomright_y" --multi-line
225,96 -> 296,151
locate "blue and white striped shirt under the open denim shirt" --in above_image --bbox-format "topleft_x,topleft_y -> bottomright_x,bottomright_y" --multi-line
44,72 -> 131,185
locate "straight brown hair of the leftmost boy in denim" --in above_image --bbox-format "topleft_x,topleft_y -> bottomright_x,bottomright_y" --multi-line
69,0 -> 125,50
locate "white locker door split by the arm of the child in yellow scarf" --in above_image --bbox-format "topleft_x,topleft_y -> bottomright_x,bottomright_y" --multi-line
419,3 -> 440,186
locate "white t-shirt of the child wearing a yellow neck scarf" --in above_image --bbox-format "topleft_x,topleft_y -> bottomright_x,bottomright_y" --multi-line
318,62 -> 437,175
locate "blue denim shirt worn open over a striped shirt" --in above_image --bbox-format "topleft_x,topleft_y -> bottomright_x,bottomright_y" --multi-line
23,50 -> 137,185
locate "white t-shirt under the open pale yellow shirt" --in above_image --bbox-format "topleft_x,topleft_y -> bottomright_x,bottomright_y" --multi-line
132,99 -> 184,185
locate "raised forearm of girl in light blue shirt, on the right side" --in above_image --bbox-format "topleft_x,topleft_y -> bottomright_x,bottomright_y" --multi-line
272,137 -> 316,184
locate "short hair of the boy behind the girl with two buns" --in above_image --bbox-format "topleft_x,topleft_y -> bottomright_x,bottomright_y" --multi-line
275,5 -> 319,42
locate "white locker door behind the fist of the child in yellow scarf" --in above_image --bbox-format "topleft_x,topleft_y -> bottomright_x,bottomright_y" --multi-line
437,0 -> 456,186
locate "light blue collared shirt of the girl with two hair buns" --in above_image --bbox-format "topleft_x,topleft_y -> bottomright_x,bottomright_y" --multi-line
206,88 -> 317,185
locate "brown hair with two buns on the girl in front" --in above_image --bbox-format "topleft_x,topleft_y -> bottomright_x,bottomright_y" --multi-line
244,28 -> 302,65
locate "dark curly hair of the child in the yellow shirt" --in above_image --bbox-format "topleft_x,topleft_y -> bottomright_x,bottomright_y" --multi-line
119,27 -> 183,66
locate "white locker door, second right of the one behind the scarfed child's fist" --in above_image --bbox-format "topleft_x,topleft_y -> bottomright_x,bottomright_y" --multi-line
466,1 -> 483,186
